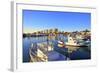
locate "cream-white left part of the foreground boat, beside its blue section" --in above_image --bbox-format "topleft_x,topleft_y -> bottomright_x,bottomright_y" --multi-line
29,42 -> 53,62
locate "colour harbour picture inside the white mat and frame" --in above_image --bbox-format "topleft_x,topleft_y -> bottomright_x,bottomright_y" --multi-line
22,10 -> 91,63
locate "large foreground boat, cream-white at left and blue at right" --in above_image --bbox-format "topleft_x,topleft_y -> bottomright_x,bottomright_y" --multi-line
29,43 -> 66,62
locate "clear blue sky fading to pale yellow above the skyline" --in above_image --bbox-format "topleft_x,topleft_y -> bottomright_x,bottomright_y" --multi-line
22,10 -> 91,33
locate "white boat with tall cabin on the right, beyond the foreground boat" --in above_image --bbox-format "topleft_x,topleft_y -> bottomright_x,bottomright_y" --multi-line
65,36 -> 88,47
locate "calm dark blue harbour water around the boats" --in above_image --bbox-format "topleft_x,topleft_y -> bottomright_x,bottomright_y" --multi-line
23,36 -> 91,62
